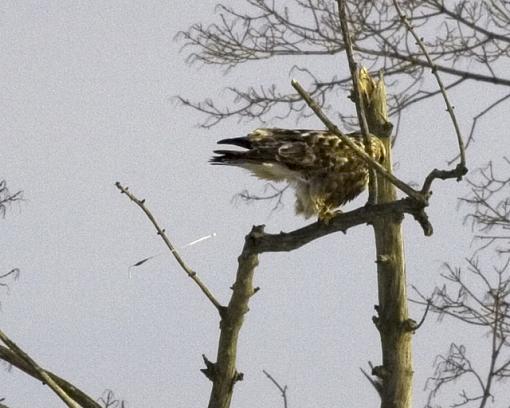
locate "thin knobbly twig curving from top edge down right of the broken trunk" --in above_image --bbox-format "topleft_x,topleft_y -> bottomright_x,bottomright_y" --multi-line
393,0 -> 467,182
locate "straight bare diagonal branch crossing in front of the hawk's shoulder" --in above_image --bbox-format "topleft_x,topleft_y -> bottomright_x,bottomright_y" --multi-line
291,79 -> 427,204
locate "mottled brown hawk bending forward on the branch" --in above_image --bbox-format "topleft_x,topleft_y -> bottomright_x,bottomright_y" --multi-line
210,128 -> 385,221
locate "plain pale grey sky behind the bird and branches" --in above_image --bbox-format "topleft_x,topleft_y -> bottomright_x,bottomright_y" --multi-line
0,0 -> 508,408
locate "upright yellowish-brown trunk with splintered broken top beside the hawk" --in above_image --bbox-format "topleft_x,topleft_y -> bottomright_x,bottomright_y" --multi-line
360,72 -> 413,408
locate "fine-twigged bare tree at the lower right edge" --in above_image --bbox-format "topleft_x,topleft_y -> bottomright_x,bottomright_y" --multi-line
418,160 -> 510,408
